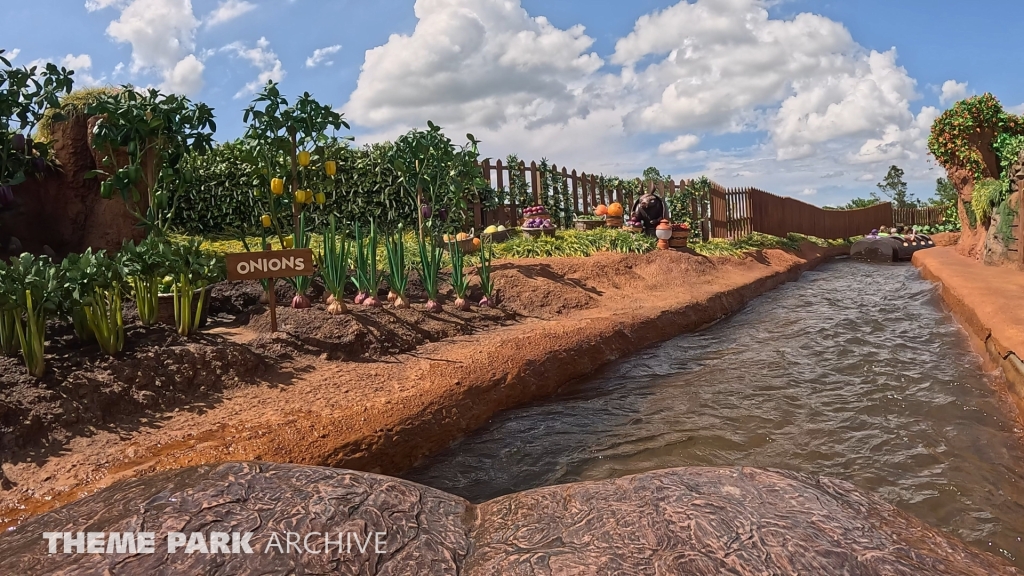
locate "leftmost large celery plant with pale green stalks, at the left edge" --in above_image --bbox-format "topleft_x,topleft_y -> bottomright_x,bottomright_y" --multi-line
3,253 -> 60,378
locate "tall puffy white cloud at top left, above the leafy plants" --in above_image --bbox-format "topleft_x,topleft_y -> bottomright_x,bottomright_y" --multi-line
99,0 -> 204,94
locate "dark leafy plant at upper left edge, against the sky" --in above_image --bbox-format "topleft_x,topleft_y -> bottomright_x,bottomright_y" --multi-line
0,49 -> 75,207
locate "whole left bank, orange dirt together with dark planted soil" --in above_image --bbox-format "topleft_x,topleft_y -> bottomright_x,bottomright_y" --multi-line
0,244 -> 848,525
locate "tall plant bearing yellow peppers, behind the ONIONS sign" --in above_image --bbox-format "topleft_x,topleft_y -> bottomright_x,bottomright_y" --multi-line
243,82 -> 349,240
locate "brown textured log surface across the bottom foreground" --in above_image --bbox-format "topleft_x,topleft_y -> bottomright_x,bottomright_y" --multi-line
0,462 -> 1020,576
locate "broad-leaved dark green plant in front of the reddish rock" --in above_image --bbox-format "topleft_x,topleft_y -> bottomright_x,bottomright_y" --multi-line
86,85 -> 217,234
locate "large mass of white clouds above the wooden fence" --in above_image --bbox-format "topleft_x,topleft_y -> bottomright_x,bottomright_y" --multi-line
345,0 -> 946,194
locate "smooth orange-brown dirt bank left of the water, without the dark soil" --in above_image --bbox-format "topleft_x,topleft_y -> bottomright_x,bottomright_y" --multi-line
0,245 -> 842,525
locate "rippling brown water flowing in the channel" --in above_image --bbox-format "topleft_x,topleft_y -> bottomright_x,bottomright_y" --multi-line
406,261 -> 1024,567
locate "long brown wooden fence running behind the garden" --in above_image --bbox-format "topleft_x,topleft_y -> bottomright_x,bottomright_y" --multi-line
472,160 -> 909,240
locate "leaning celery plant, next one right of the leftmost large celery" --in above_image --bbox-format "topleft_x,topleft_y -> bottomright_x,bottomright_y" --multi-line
82,250 -> 125,356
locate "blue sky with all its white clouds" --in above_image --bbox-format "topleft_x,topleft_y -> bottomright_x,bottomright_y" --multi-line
8,0 -> 1024,204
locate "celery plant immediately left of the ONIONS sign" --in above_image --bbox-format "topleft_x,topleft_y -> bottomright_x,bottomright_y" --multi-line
164,239 -> 224,336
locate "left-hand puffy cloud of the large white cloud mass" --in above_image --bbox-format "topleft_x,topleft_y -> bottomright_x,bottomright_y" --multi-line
345,0 -> 603,128
